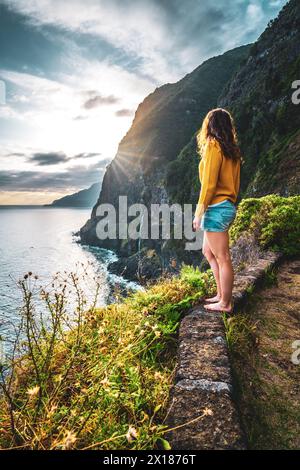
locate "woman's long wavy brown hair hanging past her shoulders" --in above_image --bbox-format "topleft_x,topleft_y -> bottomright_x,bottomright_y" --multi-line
197,108 -> 241,160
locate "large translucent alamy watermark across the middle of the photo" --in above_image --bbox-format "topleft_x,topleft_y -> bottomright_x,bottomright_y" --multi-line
96,196 -> 203,250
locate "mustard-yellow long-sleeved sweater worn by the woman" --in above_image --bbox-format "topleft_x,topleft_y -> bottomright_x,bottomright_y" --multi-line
195,139 -> 241,217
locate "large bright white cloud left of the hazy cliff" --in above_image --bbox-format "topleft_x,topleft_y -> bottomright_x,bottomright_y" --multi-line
0,64 -> 146,159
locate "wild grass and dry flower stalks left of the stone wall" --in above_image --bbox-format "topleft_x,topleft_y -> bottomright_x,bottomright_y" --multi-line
0,267 -> 214,450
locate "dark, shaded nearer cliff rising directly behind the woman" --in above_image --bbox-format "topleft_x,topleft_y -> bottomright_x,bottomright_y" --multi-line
167,0 -> 300,203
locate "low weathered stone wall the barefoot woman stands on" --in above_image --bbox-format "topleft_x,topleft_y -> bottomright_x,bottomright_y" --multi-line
166,248 -> 281,450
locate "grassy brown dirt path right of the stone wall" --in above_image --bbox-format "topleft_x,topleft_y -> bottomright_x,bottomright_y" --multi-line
229,260 -> 300,449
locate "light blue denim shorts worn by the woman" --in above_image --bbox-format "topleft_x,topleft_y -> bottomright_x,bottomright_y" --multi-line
201,199 -> 236,232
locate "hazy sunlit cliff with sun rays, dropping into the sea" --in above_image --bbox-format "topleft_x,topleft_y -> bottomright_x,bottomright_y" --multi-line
80,46 -> 250,277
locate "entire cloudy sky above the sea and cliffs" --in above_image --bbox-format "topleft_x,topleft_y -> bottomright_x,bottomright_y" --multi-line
0,0 -> 287,204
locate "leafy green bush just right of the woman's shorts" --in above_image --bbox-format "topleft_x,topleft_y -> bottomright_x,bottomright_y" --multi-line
230,194 -> 300,255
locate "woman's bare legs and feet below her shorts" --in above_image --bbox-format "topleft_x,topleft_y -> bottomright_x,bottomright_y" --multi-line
206,232 -> 233,312
